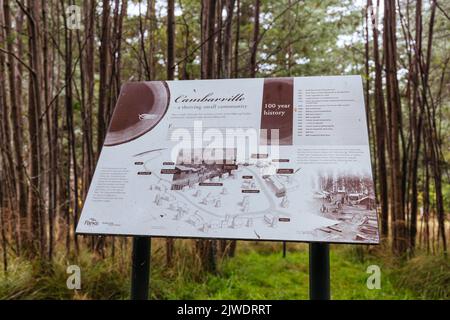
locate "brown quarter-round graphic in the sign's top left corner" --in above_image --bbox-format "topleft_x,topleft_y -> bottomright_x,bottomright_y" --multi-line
104,81 -> 170,146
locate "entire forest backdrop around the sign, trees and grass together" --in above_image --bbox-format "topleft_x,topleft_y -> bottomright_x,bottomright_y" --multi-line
0,0 -> 450,299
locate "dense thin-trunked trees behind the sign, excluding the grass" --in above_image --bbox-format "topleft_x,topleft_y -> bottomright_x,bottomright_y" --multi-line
0,0 -> 450,278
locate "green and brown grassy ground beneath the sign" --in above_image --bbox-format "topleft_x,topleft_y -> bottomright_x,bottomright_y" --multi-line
0,240 -> 450,300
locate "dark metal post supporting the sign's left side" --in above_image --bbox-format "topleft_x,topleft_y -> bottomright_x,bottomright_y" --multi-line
131,237 -> 151,300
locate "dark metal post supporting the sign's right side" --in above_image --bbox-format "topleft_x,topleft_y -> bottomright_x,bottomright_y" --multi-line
309,243 -> 330,300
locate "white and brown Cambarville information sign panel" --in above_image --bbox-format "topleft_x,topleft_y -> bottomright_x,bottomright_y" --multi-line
77,76 -> 379,244
